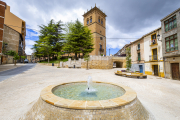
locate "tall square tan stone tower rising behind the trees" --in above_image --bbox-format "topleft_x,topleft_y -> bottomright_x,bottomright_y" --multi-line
83,5 -> 107,55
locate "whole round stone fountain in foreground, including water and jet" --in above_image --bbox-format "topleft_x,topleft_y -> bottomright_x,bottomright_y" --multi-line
21,81 -> 154,120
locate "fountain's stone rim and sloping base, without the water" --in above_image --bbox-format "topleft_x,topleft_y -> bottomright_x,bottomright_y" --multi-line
20,81 -> 154,120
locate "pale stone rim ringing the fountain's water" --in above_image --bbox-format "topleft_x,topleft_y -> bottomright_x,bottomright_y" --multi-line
40,81 -> 137,109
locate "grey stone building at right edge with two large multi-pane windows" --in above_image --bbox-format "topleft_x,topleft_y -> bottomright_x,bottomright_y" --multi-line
161,8 -> 180,80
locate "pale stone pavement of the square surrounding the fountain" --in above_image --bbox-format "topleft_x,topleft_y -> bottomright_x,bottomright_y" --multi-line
0,65 -> 180,120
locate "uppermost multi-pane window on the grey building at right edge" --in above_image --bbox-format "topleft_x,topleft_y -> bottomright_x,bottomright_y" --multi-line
164,15 -> 177,32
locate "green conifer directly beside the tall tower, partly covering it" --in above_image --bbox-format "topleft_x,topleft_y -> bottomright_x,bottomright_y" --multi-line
64,20 -> 94,59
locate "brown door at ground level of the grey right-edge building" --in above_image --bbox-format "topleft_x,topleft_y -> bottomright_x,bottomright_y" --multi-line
171,63 -> 180,80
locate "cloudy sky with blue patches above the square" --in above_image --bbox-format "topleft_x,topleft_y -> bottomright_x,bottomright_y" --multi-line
3,0 -> 180,55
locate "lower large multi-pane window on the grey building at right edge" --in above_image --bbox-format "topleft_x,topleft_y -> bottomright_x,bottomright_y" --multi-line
165,34 -> 178,52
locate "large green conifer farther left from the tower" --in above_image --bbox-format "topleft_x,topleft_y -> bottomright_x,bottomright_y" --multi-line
32,20 -> 64,62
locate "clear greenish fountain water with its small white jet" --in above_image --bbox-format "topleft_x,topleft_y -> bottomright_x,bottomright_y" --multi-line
53,76 -> 125,101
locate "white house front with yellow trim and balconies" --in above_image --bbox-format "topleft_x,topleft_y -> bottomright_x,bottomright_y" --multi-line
144,27 -> 164,77
